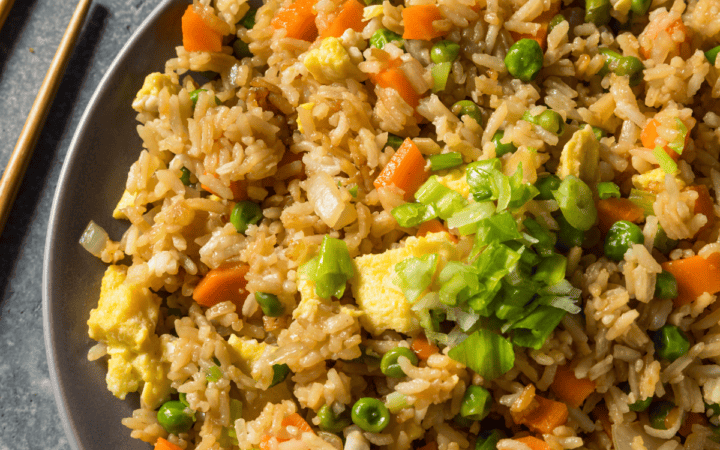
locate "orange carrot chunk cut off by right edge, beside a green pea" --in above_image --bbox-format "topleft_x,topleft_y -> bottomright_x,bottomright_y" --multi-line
661,253 -> 720,307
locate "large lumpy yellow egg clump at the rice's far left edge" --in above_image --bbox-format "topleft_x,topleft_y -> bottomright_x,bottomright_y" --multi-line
87,266 -> 171,409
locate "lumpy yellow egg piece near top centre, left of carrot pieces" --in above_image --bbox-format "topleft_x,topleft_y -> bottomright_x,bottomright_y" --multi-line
303,37 -> 358,84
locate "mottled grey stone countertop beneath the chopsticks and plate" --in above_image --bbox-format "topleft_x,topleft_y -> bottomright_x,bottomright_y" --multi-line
0,0 -> 160,450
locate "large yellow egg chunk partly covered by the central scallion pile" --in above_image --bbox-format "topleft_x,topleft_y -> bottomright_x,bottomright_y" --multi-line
351,233 -> 460,335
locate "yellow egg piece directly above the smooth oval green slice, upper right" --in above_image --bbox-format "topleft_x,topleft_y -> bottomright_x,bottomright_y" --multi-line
557,125 -> 600,187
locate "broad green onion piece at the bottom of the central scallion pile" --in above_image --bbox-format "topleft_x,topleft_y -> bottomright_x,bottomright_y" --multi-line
448,329 -> 515,381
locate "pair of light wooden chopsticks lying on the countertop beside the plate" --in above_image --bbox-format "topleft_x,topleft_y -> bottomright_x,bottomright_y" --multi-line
0,0 -> 90,234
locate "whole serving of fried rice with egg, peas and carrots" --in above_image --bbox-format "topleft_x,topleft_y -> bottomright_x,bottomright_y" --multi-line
83,0 -> 720,450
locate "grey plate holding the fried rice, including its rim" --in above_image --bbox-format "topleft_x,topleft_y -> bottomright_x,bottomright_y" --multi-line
43,0 -> 189,450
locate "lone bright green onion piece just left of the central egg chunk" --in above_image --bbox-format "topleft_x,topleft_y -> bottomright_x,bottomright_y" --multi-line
302,235 -> 355,298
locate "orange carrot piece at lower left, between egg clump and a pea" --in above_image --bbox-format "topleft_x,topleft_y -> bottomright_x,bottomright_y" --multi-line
193,263 -> 250,308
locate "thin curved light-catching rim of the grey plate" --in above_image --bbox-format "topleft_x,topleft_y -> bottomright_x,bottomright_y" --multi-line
42,0 -> 187,450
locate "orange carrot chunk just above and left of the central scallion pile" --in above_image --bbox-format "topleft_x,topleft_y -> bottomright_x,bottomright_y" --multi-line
373,138 -> 427,200
